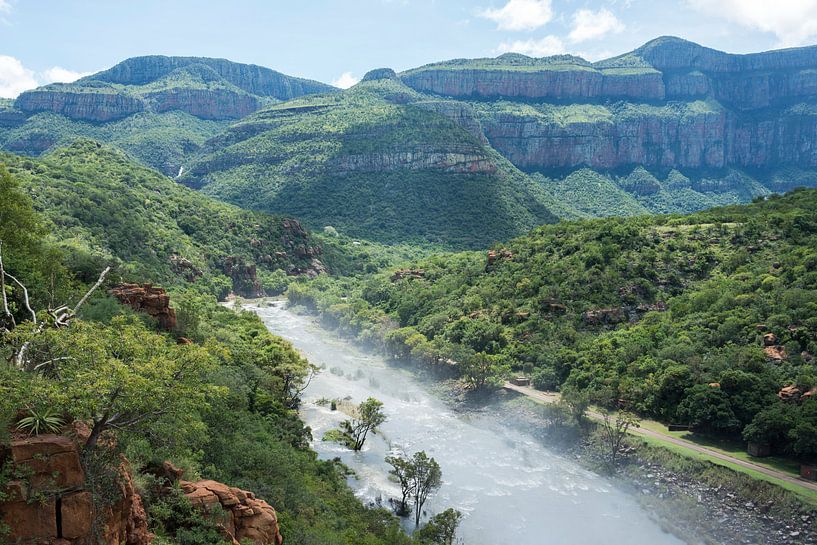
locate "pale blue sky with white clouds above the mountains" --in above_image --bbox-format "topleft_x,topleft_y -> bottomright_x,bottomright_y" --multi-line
0,0 -> 817,98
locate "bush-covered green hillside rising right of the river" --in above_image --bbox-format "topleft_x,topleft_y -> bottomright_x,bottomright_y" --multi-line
289,186 -> 817,460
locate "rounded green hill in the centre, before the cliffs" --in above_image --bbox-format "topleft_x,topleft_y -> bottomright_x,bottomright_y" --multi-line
181,79 -> 555,247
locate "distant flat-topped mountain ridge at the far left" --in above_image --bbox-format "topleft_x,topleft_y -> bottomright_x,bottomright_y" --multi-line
0,55 -> 336,175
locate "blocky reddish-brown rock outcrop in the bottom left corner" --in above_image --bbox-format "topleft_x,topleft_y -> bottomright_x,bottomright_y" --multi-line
0,427 -> 153,545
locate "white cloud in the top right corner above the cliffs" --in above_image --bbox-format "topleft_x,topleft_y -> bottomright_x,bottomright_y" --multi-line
687,0 -> 817,47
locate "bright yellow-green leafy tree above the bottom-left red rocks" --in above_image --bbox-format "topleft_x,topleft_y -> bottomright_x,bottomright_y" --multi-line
12,317 -> 221,449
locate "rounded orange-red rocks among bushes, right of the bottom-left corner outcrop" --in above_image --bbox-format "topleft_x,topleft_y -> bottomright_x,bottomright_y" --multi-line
179,481 -> 283,545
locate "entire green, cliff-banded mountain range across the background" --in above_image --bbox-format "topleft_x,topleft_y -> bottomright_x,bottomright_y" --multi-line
0,37 -> 817,247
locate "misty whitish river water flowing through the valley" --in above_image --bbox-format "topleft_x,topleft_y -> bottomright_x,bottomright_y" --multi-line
250,301 -> 682,545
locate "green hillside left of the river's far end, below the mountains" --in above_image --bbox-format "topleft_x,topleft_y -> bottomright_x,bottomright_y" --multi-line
0,141 -> 324,297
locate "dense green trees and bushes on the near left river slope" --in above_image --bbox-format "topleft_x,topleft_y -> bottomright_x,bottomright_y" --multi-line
0,150 -> 410,545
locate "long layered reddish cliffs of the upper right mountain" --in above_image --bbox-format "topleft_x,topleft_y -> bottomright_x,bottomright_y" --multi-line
400,38 -> 817,170
